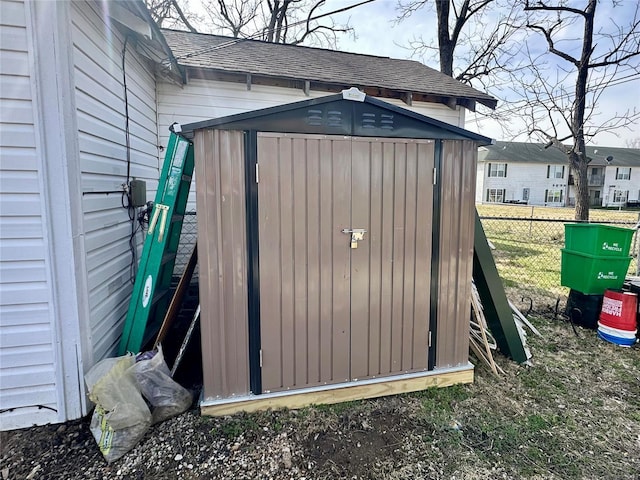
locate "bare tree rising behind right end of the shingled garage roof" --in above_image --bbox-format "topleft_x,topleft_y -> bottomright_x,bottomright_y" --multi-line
397,0 -> 526,142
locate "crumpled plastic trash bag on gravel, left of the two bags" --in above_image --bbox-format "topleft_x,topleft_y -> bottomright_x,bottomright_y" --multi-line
84,355 -> 151,463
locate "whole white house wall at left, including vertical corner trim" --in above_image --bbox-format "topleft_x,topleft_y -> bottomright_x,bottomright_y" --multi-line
0,0 -> 158,430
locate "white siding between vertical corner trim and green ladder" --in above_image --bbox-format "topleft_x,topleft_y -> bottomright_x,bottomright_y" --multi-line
72,3 -> 159,361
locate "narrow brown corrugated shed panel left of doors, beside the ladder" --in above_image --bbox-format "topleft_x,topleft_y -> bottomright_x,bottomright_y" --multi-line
194,130 -> 249,399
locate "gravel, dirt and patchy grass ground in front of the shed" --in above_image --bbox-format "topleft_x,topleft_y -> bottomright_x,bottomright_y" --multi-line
0,319 -> 640,480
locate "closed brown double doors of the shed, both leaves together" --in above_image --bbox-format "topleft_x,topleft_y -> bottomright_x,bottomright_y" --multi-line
257,133 -> 434,393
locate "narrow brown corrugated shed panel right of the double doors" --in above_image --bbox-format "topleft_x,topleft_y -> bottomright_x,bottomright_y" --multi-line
436,140 -> 477,368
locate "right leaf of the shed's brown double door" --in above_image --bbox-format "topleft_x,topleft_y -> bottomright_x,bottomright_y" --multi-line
351,138 -> 434,378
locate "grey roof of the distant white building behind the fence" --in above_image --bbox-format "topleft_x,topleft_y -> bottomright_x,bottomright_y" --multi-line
478,142 -> 640,167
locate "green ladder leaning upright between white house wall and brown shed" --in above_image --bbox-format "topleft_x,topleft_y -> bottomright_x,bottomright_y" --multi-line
118,129 -> 194,355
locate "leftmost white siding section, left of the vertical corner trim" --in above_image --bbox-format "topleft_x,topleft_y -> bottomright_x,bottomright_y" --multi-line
0,0 -> 60,430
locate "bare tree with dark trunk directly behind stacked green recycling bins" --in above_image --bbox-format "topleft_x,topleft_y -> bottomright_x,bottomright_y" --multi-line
519,0 -> 640,220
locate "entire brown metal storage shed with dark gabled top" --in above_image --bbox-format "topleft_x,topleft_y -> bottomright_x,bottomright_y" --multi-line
183,89 -> 491,415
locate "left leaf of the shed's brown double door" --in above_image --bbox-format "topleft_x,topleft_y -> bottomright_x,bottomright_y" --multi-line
258,134 -> 351,391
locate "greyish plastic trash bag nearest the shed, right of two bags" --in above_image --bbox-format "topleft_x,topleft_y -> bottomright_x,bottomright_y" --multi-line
133,346 -> 193,423
